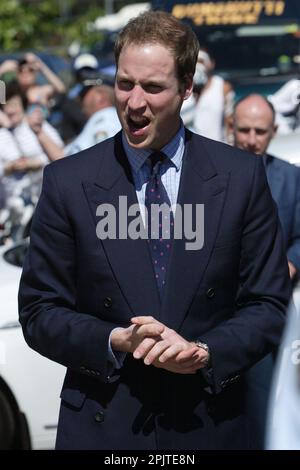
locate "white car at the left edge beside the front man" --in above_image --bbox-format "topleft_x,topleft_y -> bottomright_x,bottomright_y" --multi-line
0,242 -> 65,450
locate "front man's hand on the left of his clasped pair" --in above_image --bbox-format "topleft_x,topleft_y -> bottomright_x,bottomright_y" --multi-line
111,321 -> 164,353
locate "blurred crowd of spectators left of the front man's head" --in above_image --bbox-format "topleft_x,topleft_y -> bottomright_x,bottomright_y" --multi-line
0,53 -> 120,240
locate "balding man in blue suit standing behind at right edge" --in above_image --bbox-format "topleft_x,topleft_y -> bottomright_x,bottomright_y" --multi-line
233,94 -> 300,279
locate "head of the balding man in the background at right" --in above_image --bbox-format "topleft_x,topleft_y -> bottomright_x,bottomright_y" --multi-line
233,97 -> 276,155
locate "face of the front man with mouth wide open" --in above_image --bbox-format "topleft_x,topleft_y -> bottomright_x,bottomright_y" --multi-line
115,44 -> 192,150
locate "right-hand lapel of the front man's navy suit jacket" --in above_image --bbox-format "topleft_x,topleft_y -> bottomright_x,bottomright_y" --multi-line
161,133 -> 229,330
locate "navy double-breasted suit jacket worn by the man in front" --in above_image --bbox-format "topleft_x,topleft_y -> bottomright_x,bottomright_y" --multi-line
19,132 -> 290,449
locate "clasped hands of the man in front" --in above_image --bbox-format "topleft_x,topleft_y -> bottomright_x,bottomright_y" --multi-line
111,316 -> 208,374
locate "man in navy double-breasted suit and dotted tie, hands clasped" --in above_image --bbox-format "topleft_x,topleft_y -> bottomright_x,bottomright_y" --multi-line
19,12 -> 290,450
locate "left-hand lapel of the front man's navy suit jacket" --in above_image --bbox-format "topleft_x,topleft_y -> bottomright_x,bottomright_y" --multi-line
83,134 -> 160,318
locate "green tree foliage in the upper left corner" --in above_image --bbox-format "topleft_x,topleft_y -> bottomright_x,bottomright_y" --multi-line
0,0 -> 103,51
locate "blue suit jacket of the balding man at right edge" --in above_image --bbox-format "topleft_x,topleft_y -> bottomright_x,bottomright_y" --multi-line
266,155 -> 300,274
